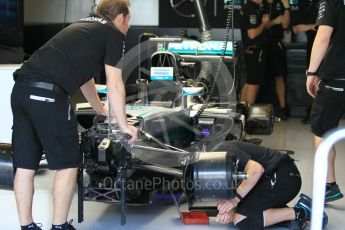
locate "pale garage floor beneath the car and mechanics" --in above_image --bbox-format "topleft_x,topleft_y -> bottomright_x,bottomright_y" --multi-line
0,119 -> 345,230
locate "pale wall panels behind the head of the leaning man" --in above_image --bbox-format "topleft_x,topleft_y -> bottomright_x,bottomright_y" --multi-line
24,0 -> 159,26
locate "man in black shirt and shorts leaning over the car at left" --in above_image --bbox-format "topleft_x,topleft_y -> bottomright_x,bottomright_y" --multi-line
11,0 -> 137,230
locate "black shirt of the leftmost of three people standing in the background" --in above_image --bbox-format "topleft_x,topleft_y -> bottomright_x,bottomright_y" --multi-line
242,0 -> 268,46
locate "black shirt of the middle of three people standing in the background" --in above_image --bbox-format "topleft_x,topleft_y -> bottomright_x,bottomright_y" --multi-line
267,0 -> 285,41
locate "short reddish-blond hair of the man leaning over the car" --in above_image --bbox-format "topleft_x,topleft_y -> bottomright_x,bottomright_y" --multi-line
96,0 -> 130,21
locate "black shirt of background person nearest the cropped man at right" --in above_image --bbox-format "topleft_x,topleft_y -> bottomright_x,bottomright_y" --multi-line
290,0 -> 319,26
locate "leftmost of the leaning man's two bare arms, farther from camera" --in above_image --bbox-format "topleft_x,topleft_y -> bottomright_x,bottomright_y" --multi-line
80,78 -> 108,116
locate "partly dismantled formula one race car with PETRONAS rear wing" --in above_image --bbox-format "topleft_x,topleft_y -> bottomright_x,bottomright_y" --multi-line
72,23 -> 273,224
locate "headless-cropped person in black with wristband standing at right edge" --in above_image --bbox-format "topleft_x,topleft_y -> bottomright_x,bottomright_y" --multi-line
306,0 -> 345,203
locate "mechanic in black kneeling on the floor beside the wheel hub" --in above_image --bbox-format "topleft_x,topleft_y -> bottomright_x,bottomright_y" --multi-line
212,141 -> 328,230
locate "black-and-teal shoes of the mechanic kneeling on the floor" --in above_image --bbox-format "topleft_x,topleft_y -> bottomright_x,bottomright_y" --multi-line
294,193 -> 328,228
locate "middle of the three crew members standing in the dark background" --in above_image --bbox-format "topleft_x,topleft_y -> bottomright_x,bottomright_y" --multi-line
267,0 -> 290,120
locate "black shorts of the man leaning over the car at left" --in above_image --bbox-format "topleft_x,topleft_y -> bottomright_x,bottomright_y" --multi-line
11,80 -> 82,170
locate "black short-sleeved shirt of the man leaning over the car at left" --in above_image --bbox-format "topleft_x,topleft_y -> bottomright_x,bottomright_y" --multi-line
14,15 -> 124,95
